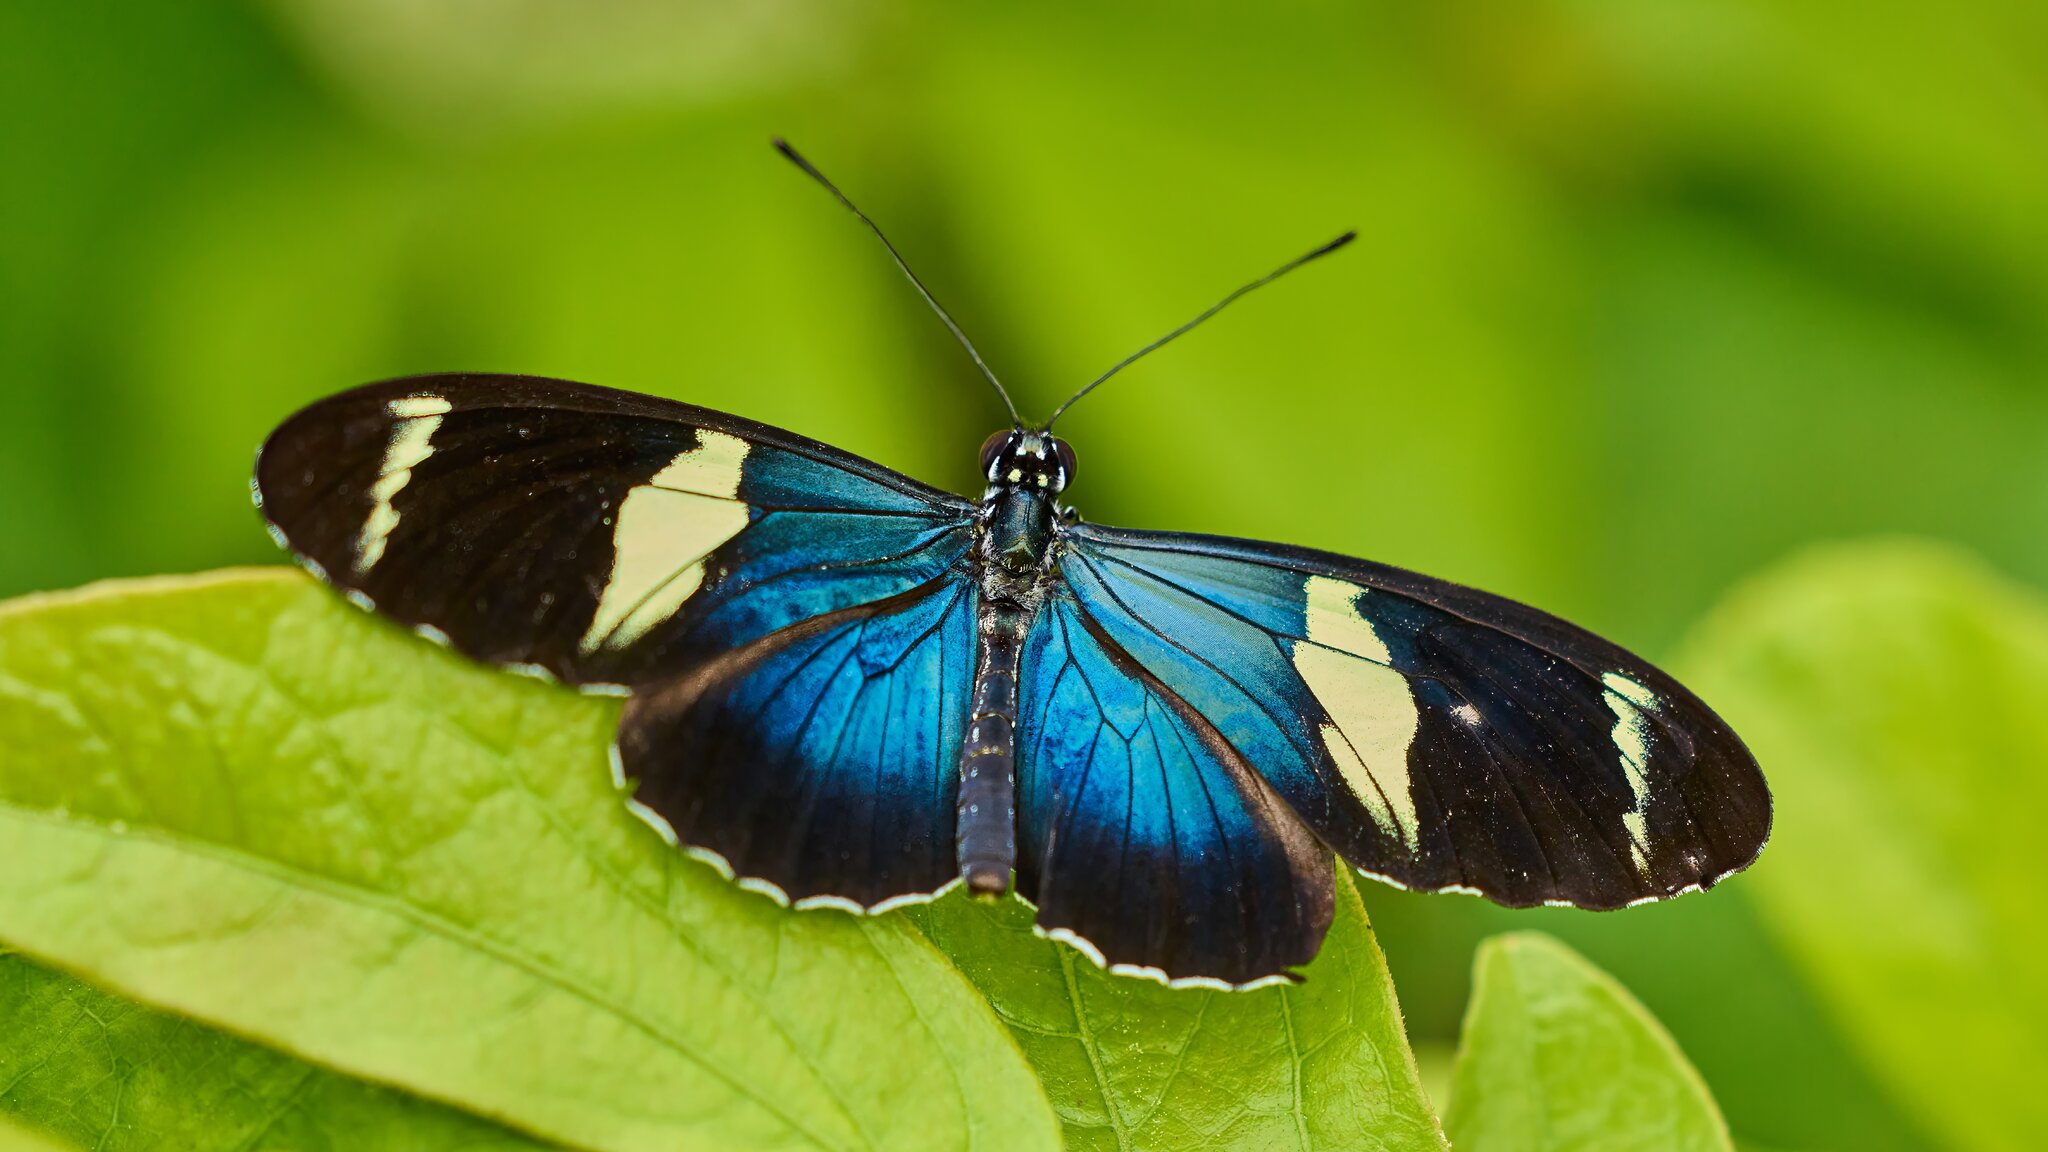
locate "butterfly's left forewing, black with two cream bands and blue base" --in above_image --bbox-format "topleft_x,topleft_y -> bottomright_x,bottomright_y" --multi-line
256,375 -> 973,685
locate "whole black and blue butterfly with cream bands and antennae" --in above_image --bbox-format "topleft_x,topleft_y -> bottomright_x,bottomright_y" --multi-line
254,141 -> 1772,988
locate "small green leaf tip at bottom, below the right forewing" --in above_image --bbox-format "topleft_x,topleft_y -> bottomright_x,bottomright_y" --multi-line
1444,933 -> 1733,1152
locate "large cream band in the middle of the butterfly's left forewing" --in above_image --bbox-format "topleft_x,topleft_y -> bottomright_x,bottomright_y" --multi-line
580,428 -> 750,654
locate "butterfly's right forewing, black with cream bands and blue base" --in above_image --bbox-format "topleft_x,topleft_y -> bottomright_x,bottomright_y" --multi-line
1061,525 -> 1772,908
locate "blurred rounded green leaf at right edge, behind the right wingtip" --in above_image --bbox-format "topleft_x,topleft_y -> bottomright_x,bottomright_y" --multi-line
1686,543 -> 2048,1150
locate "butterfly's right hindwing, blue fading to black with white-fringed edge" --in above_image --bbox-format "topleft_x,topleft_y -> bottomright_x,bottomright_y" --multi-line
1018,594 -> 1333,984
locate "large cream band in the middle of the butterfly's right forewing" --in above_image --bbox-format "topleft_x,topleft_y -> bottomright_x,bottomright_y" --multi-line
1292,576 -> 1421,853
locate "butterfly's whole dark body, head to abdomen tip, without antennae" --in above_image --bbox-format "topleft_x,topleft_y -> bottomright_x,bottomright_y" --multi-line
956,428 -> 1073,896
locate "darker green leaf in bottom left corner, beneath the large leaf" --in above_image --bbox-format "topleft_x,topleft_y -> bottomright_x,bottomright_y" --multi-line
0,955 -> 549,1152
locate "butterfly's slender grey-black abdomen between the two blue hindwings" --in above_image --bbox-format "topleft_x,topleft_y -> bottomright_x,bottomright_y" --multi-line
954,603 -> 1030,898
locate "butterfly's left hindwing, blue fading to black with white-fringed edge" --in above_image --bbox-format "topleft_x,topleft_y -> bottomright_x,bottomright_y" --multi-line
618,578 -> 975,908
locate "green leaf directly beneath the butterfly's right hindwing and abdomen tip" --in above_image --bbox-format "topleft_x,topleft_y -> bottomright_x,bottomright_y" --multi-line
911,865 -> 1444,1152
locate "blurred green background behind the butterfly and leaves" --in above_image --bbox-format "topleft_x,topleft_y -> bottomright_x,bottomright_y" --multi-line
0,0 -> 2048,1150
